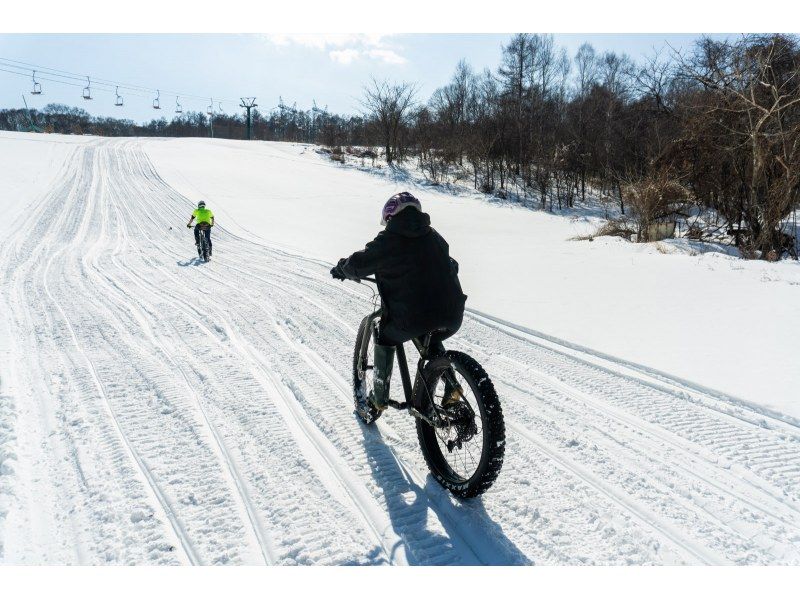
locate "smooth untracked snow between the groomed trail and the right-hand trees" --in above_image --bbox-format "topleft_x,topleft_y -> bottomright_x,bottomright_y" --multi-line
145,139 -> 800,422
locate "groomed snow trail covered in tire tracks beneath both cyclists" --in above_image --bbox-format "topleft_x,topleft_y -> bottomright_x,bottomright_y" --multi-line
0,138 -> 800,565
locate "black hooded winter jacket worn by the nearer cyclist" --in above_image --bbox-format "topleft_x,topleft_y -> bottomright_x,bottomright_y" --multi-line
341,208 -> 467,344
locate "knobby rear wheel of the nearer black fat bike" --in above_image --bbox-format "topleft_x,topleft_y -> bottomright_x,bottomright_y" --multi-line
417,351 -> 505,498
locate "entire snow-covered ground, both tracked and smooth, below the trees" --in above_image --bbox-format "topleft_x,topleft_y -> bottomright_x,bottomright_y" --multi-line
0,133 -> 800,564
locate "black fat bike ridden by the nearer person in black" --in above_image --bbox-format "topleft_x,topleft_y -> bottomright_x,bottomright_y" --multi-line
353,278 -> 505,498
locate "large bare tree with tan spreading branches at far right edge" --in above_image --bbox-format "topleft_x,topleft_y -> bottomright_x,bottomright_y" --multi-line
680,35 -> 800,257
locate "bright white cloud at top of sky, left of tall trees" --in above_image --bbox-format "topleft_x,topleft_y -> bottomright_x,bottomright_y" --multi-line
265,33 -> 408,64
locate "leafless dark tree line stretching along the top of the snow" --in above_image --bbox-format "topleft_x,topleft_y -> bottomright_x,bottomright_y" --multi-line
0,33 -> 800,259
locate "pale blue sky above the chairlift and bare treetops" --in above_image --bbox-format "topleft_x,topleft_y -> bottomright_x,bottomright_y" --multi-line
0,33 -> 724,121
